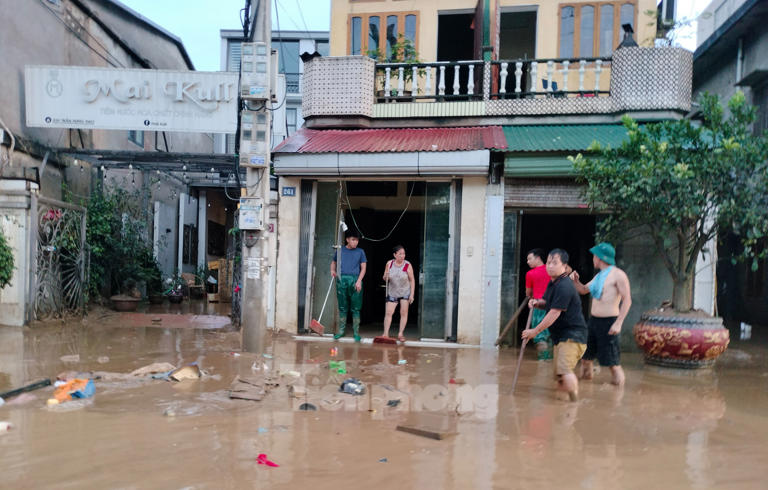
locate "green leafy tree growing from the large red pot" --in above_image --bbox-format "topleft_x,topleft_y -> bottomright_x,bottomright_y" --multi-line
571,92 -> 768,312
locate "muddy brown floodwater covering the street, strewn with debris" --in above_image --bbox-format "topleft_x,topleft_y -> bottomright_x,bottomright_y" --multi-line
0,313 -> 768,490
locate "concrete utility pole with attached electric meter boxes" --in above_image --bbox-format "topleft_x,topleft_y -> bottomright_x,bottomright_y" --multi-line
238,0 -> 277,352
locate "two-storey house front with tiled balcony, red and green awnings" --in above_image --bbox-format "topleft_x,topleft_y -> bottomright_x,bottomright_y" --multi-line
274,0 -> 691,346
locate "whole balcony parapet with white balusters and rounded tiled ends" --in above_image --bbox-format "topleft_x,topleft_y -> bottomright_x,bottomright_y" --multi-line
302,47 -> 693,120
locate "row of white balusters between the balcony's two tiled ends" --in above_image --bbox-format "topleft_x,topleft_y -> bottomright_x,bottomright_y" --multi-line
375,58 -> 611,102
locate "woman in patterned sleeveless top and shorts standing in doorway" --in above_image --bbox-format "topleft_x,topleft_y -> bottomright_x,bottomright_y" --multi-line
384,245 -> 416,342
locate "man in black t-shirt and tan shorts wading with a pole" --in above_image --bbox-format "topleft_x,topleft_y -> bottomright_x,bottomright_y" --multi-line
522,248 -> 587,401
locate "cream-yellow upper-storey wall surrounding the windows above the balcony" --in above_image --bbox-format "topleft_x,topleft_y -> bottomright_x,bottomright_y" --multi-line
330,0 -> 656,61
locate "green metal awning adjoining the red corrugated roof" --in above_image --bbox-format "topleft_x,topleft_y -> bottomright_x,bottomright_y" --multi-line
503,124 -> 627,177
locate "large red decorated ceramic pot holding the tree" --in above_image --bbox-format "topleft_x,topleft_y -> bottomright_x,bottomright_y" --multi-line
634,310 -> 730,369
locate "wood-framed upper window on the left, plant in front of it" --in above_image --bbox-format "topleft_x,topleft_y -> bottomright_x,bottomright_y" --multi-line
347,12 -> 418,59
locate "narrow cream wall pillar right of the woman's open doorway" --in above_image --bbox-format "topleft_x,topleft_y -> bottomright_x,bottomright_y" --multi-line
456,177 -> 488,344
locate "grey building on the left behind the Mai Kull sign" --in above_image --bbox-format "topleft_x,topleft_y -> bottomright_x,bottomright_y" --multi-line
0,0 -> 219,325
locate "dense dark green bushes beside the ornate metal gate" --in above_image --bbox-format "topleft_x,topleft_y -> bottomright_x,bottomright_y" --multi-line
81,187 -> 163,295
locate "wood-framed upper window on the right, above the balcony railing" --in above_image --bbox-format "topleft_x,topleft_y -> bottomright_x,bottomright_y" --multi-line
558,0 -> 637,58
